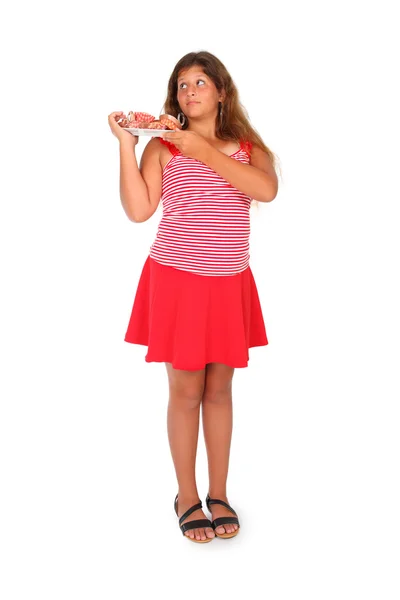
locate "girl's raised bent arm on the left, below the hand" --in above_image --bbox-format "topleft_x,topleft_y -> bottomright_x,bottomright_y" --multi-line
119,138 -> 162,223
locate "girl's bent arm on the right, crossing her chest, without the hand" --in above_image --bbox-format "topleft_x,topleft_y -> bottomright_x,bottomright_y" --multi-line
199,144 -> 278,202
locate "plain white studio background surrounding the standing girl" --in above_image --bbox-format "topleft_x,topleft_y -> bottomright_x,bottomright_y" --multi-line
0,0 -> 400,600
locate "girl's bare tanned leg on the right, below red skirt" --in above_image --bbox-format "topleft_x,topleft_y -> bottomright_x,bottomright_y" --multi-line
202,363 -> 238,533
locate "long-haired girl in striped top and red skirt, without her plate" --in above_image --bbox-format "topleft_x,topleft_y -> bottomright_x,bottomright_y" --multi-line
108,51 -> 278,543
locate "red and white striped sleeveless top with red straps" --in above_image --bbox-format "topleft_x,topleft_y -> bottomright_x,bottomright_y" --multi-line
150,138 -> 252,276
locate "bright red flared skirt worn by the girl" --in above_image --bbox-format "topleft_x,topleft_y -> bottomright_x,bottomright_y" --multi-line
124,256 -> 268,371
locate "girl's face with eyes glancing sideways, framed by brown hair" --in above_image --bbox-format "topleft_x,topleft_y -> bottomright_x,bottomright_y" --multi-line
177,65 -> 223,118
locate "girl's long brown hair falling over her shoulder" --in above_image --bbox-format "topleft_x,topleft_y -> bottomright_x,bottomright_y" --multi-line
163,50 -> 277,204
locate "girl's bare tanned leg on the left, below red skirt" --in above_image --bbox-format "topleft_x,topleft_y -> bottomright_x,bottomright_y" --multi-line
165,363 -> 215,540
